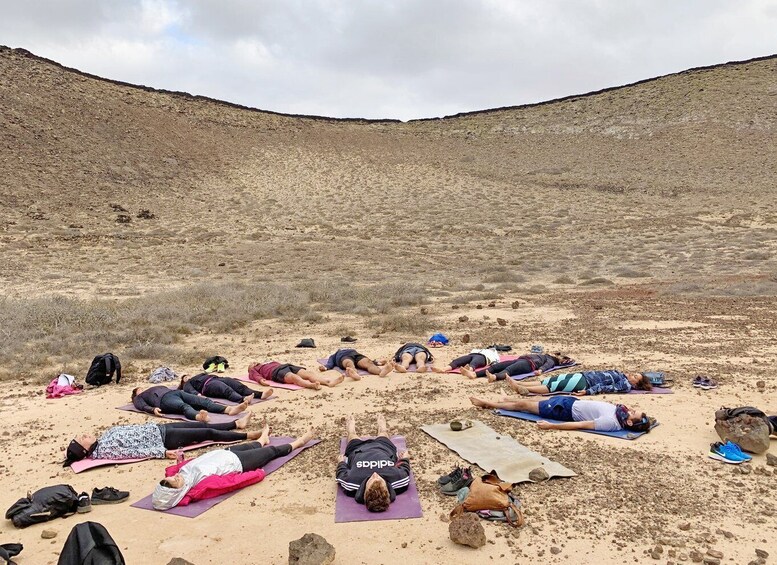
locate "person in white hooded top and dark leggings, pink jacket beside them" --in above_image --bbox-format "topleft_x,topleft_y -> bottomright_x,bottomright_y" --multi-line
151,425 -> 313,510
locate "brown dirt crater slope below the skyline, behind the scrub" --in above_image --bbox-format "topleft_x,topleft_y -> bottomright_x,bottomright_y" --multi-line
0,48 -> 777,295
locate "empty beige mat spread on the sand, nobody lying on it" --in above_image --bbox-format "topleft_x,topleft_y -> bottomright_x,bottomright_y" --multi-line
421,420 -> 575,483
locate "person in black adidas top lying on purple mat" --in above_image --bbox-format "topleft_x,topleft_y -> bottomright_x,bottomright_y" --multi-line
337,414 -> 410,512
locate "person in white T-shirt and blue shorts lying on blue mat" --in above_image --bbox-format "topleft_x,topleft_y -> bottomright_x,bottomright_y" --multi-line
469,396 -> 653,432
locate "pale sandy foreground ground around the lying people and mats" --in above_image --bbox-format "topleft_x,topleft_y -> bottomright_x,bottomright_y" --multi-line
0,296 -> 777,564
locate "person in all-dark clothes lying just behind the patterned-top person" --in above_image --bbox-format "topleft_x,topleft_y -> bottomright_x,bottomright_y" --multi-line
132,385 -> 250,422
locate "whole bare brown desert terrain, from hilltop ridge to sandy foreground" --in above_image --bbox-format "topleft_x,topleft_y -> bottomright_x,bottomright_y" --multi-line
0,48 -> 777,565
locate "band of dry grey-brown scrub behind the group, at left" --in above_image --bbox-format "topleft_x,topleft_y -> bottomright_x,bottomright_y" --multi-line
0,281 -> 425,376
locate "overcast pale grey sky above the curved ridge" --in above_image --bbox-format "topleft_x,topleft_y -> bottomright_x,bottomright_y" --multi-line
0,0 -> 777,120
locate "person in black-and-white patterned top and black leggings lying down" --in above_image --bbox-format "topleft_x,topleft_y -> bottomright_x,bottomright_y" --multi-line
65,412 -> 261,467
